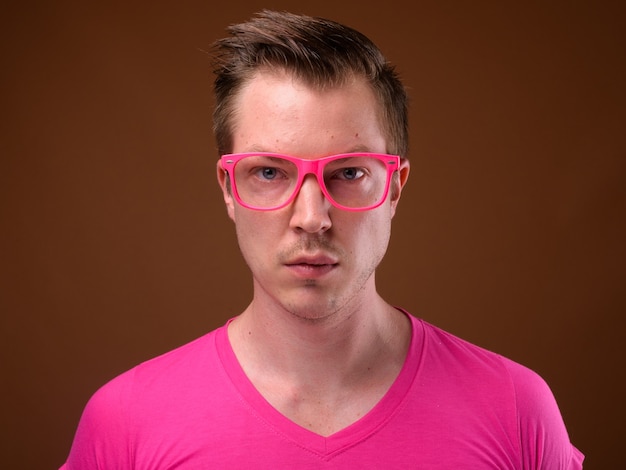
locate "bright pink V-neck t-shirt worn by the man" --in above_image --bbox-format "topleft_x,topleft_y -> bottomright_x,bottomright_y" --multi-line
62,315 -> 583,470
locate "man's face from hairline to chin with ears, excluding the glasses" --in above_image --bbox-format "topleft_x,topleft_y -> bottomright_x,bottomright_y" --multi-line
218,72 -> 408,319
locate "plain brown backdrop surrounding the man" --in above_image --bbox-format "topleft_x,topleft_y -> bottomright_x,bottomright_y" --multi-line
0,0 -> 626,469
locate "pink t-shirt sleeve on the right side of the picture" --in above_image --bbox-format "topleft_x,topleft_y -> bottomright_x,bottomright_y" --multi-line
506,361 -> 584,470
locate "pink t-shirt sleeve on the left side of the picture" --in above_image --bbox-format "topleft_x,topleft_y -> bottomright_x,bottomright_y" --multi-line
61,371 -> 132,470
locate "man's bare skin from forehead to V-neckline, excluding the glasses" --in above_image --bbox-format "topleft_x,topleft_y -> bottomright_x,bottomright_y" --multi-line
217,70 -> 410,436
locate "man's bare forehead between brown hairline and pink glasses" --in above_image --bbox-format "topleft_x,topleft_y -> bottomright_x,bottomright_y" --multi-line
233,71 -> 386,155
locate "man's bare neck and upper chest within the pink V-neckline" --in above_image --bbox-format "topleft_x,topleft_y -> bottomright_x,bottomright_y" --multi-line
228,284 -> 411,435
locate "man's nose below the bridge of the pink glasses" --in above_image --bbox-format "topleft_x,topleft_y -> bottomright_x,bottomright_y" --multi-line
290,175 -> 332,233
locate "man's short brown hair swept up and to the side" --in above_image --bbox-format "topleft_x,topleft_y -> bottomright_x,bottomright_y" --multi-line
207,10 -> 408,156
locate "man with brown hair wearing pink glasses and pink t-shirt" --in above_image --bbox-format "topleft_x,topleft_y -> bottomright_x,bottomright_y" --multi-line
65,11 -> 583,470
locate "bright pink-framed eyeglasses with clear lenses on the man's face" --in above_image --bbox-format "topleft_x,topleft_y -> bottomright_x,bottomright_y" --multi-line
221,152 -> 400,211
